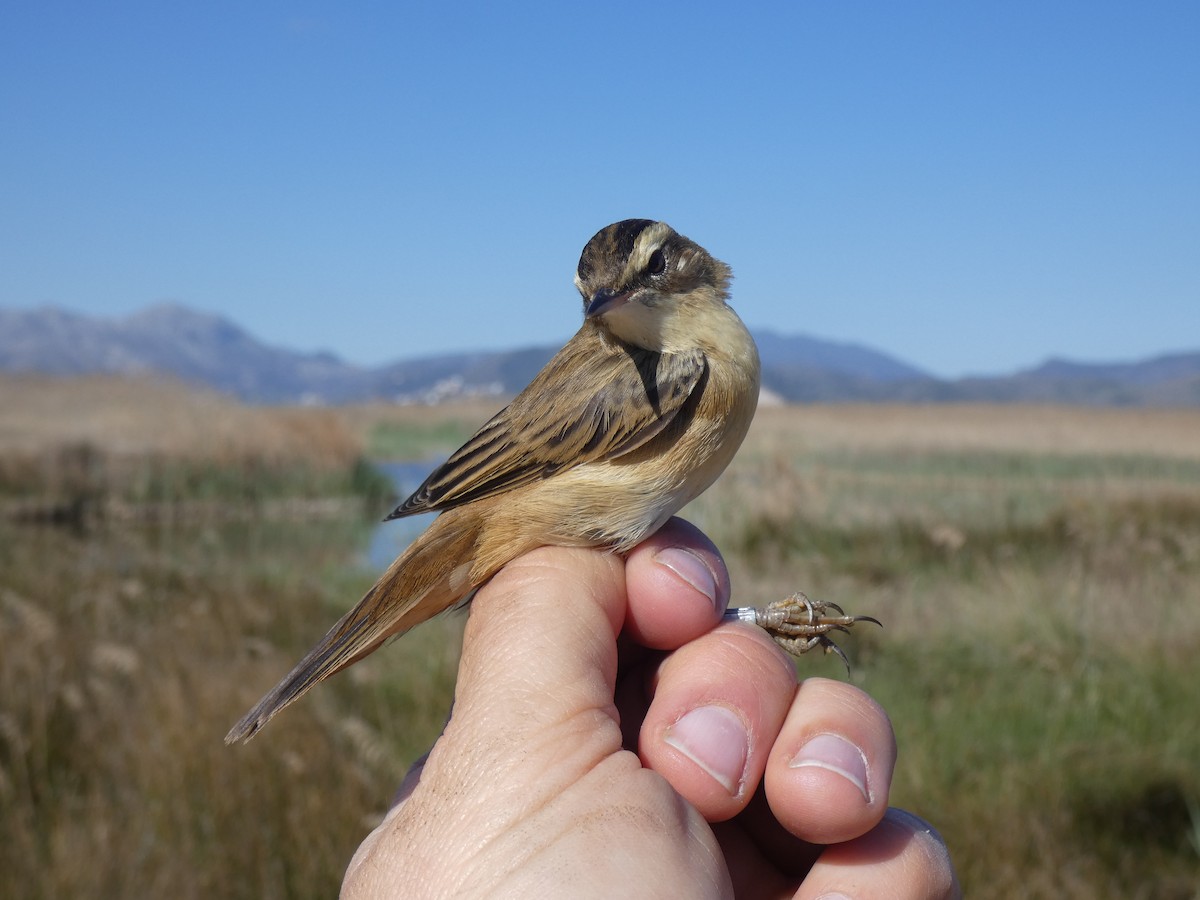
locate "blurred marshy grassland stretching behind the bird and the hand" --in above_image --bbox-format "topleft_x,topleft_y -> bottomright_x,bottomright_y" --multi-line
0,379 -> 1200,899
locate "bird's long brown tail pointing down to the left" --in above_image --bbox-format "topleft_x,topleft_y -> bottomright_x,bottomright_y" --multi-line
226,510 -> 479,744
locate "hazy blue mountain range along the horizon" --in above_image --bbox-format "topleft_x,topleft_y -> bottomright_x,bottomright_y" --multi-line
0,305 -> 1200,407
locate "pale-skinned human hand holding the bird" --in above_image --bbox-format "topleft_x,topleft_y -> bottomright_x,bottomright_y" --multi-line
342,520 -> 959,900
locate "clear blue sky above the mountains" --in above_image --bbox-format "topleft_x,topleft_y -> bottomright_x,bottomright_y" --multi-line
0,0 -> 1200,376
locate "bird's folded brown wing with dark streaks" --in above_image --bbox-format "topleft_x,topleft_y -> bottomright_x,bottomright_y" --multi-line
388,331 -> 706,518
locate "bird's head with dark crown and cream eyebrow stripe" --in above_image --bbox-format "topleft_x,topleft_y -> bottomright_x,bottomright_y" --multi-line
575,218 -> 732,353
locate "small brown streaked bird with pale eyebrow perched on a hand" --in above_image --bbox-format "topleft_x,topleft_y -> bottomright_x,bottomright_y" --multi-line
226,218 -> 761,744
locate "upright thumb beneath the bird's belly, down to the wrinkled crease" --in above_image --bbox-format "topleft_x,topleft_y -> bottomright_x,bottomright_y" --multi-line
454,547 -> 625,743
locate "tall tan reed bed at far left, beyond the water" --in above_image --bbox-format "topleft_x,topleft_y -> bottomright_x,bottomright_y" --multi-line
0,376 -> 385,524
